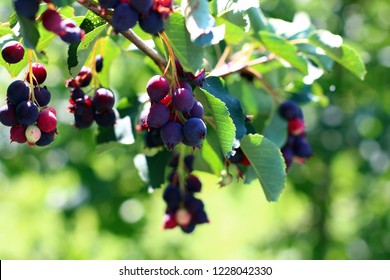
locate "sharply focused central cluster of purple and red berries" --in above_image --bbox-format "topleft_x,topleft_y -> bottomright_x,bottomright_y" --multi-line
140,75 -> 207,150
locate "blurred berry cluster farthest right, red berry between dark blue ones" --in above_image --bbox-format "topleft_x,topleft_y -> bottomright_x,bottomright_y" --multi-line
279,100 -> 312,169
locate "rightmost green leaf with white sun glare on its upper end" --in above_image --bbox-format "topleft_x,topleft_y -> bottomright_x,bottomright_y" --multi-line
308,30 -> 367,80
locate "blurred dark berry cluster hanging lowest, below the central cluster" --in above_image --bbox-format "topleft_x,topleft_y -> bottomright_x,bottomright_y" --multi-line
163,155 -> 209,233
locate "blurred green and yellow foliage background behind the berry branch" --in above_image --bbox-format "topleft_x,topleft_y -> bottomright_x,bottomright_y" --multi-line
0,0 -> 390,259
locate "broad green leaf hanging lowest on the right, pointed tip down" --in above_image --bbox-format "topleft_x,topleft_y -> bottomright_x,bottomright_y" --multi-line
240,134 -> 286,201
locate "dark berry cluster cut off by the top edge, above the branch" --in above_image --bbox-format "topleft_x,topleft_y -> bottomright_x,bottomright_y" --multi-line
99,0 -> 172,35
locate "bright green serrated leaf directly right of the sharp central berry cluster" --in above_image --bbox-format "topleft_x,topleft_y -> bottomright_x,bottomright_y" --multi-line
197,86 -> 236,156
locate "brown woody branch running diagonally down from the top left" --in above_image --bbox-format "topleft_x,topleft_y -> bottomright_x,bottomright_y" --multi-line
77,0 -> 167,71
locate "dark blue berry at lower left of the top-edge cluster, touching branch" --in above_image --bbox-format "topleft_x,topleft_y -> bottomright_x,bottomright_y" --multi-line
112,3 -> 139,32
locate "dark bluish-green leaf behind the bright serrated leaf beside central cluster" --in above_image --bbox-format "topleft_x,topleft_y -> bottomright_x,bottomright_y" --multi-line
202,77 -> 246,140
